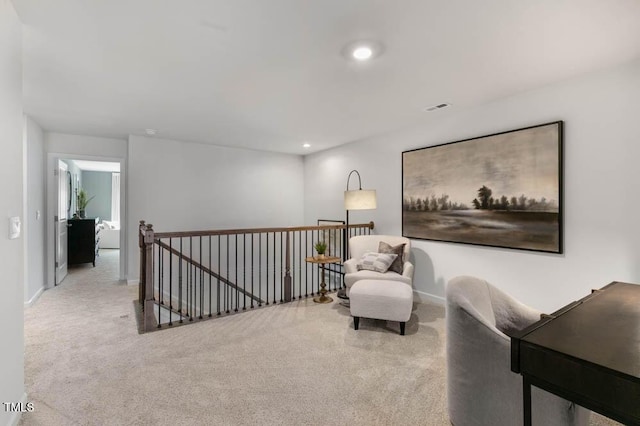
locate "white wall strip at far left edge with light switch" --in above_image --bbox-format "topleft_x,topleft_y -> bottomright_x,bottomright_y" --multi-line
0,0 -> 25,425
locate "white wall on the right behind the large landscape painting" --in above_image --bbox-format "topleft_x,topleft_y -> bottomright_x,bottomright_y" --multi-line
305,62 -> 640,312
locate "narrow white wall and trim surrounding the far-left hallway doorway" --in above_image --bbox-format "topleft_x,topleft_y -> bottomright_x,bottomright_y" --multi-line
44,132 -> 127,287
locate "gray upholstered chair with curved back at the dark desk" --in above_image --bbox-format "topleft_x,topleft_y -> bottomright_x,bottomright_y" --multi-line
446,276 -> 590,426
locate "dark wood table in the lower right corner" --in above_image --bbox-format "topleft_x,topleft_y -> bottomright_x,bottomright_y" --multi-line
511,282 -> 640,426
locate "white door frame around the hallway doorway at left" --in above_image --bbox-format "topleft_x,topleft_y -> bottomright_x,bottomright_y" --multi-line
45,152 -> 128,288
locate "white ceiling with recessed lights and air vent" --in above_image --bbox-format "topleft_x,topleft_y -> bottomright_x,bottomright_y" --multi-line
12,0 -> 640,154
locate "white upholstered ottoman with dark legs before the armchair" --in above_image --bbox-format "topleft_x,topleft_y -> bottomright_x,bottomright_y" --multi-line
349,280 -> 413,336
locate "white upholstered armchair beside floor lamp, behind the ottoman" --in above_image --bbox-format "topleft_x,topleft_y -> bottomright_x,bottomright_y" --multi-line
344,235 -> 413,296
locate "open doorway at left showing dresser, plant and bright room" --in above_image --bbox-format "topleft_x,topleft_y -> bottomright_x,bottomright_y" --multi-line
47,154 -> 126,287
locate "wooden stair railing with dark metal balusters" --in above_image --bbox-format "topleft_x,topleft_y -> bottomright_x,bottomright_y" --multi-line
139,221 -> 374,331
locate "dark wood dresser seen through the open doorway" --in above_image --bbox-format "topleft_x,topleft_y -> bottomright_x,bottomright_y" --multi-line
67,218 -> 100,266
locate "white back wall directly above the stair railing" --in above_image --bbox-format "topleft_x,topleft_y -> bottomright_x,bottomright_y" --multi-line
128,136 -> 304,280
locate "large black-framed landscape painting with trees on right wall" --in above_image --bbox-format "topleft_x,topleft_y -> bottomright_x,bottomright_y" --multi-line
402,121 -> 563,253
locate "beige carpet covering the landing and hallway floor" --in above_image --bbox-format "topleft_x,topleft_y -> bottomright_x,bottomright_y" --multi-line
21,250 -> 615,426
